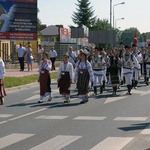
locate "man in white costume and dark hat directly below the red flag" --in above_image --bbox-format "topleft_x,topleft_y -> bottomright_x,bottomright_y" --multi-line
132,44 -> 143,89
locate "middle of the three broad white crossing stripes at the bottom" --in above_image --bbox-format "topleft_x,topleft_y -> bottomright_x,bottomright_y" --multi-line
29,135 -> 81,150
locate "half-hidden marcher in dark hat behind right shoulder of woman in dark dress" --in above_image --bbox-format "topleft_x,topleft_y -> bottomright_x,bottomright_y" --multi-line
117,42 -> 125,85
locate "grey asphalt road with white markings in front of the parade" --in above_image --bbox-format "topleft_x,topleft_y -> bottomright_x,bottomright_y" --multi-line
0,80 -> 150,150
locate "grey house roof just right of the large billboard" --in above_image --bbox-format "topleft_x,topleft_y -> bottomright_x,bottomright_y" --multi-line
40,25 -> 58,36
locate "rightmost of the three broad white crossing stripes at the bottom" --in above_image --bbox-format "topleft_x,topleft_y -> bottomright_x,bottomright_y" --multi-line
91,137 -> 133,150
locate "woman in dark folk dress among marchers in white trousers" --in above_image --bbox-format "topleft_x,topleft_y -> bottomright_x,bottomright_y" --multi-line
108,50 -> 121,95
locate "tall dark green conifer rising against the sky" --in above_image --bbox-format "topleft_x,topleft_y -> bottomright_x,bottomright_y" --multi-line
71,0 -> 96,28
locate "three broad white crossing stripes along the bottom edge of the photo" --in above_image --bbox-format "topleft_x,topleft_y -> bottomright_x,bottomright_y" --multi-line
0,133 -> 150,150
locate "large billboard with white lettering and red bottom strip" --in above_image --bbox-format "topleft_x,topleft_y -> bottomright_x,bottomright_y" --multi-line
0,0 -> 37,40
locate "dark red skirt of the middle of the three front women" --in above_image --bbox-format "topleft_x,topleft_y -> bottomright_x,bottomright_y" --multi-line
58,72 -> 71,95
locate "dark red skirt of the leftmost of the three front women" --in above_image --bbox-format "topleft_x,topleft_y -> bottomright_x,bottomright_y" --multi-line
40,69 -> 51,96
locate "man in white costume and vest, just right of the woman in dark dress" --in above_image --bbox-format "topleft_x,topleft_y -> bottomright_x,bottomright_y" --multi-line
121,46 -> 139,95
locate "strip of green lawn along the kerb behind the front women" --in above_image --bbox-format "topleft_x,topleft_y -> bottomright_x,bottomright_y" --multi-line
4,72 -> 57,88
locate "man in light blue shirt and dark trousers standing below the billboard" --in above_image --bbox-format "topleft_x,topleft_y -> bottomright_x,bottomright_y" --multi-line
17,43 -> 26,71
